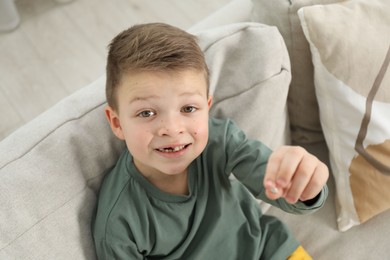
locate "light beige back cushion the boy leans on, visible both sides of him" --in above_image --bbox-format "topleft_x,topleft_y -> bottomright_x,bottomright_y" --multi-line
0,24 -> 290,260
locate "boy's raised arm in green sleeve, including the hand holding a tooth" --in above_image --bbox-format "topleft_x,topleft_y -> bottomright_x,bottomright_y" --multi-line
221,119 -> 329,214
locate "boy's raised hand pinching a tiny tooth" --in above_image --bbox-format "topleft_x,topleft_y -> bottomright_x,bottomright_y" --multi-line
264,146 -> 329,204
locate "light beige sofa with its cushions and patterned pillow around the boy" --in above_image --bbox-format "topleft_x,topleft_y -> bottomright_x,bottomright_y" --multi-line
0,0 -> 390,260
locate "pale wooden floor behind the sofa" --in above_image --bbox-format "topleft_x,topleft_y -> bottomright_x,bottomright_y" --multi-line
0,0 -> 230,140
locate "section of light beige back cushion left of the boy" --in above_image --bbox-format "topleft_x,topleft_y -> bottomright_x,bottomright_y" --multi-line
0,78 -> 123,259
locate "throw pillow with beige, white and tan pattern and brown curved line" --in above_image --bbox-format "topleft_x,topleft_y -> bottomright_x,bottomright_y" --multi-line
299,0 -> 390,231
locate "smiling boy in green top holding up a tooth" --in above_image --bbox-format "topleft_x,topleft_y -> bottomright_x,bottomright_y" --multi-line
93,24 -> 328,260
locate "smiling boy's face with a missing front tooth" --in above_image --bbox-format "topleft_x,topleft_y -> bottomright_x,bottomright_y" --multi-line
106,70 -> 211,178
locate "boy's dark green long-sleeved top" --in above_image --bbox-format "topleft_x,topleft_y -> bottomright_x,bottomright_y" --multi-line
93,119 -> 327,260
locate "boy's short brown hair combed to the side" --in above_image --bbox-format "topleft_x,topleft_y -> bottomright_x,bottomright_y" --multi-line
106,23 -> 209,110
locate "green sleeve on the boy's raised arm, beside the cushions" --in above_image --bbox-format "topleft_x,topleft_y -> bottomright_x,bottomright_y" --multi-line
221,121 -> 328,214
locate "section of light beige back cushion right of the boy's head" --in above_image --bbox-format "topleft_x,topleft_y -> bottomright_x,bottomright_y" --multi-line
198,23 -> 291,148
